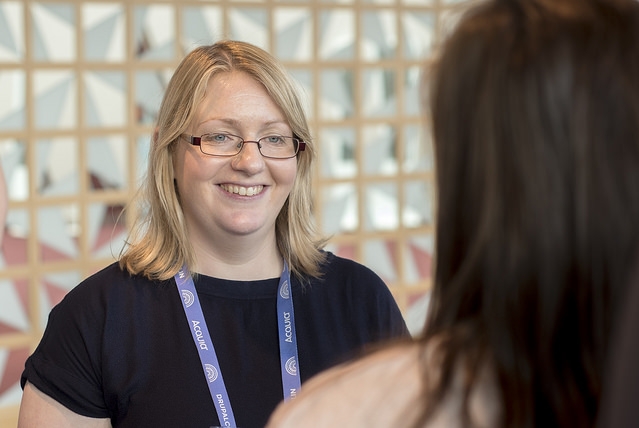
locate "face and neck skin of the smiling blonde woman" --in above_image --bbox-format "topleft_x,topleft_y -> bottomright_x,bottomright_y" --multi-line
174,72 -> 297,280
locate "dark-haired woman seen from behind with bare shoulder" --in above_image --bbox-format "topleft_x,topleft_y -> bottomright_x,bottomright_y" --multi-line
269,0 -> 639,427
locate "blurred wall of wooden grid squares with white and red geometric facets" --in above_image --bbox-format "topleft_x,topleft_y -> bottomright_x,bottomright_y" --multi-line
0,0 -> 476,426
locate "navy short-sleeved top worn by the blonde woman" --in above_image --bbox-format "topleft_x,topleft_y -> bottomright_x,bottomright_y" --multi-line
22,253 -> 408,428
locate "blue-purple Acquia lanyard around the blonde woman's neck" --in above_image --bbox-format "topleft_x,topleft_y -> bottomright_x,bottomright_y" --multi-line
175,261 -> 301,427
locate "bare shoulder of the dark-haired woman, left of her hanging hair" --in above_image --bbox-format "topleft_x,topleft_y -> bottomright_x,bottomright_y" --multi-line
269,342 -> 421,428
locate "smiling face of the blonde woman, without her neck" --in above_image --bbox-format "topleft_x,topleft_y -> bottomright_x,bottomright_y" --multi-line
174,72 -> 297,245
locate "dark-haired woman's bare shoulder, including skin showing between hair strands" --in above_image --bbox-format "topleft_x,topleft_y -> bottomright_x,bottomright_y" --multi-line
268,341 -> 499,428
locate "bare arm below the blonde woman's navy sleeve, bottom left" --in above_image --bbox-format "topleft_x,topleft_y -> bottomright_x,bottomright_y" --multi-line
18,382 -> 111,428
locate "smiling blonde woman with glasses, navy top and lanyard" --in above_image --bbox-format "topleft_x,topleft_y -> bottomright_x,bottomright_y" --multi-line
19,41 -> 408,428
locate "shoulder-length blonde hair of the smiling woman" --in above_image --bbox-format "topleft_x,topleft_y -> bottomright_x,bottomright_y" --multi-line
120,41 -> 326,280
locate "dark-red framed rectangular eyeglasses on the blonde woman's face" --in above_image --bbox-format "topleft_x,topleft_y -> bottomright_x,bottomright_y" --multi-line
182,133 -> 306,159
